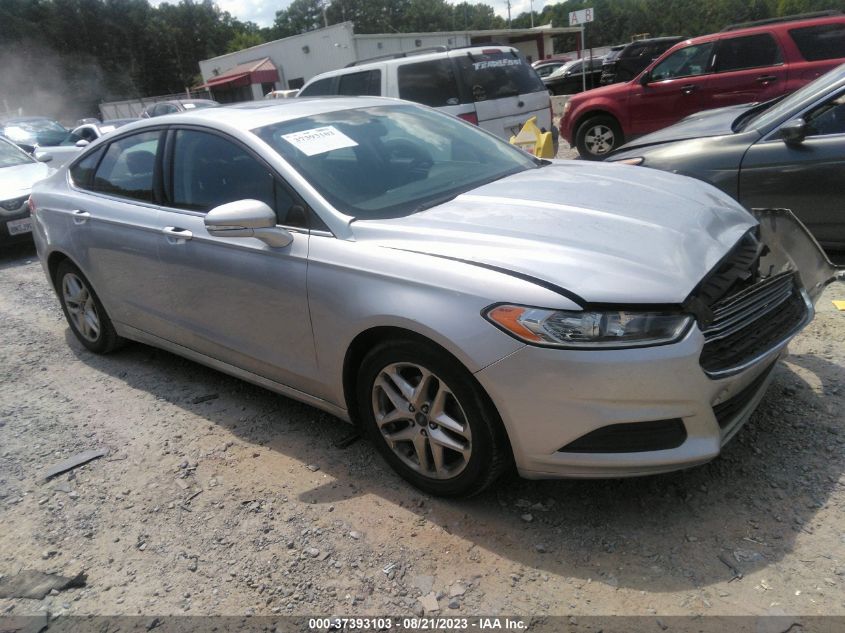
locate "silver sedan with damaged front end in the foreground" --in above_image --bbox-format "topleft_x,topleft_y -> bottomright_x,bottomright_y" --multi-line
32,98 -> 835,495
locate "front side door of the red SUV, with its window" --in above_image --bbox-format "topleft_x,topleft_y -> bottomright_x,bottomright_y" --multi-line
625,42 -> 714,137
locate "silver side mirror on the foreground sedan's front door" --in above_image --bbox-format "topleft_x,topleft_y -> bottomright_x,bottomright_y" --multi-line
205,199 -> 293,248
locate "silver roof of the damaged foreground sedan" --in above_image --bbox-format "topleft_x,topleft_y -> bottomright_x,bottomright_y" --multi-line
121,97 -> 398,131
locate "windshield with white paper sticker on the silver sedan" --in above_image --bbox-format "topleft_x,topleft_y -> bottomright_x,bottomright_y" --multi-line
253,105 -> 540,220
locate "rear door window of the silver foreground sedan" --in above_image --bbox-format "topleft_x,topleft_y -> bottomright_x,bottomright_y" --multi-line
90,130 -> 161,202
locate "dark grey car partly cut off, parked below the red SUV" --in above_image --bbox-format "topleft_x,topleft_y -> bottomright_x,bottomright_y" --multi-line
608,64 -> 845,250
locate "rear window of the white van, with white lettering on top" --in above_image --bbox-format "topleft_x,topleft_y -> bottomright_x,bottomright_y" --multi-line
453,51 -> 547,101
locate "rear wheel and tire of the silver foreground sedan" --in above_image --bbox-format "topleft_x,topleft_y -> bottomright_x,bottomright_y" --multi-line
56,259 -> 125,354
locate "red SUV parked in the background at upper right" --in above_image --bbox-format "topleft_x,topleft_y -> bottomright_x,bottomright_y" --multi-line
560,12 -> 845,160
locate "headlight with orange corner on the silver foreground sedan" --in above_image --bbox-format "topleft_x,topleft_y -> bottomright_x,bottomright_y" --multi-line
484,305 -> 692,349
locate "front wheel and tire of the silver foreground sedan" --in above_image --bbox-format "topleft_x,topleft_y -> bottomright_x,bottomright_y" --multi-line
356,340 -> 511,497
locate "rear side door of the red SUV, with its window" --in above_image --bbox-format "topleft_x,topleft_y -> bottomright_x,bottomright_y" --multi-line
703,33 -> 787,110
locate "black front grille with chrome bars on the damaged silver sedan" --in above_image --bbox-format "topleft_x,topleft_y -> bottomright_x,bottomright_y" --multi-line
699,272 -> 807,375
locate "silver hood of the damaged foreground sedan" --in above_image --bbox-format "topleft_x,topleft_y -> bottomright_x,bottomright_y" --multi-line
352,161 -> 756,304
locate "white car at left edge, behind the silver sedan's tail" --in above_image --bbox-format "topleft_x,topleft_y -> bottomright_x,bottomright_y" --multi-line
0,136 -> 51,247
